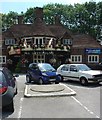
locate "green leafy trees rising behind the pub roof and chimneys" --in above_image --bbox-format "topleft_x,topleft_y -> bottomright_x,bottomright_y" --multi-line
0,1 -> 102,37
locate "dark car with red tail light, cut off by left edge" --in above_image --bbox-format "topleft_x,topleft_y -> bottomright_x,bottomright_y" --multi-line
0,67 -> 18,112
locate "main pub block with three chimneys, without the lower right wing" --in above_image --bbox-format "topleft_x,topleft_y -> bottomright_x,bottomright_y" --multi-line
2,7 -> 73,70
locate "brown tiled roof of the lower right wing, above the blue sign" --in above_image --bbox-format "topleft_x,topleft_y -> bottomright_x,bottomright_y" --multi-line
73,34 -> 102,48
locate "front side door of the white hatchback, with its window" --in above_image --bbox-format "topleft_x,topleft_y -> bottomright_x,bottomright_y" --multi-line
69,65 -> 79,81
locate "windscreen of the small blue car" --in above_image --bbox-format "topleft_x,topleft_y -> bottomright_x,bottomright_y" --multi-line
38,64 -> 56,72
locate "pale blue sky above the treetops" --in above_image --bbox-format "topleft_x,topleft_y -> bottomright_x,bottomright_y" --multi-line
0,0 -> 101,14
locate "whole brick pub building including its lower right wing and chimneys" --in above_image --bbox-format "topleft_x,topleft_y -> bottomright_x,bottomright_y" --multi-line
0,7 -> 102,72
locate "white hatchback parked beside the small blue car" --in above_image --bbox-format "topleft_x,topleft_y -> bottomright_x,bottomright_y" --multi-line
57,64 -> 102,85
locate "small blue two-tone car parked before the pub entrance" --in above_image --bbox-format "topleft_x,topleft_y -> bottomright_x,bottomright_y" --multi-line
26,63 -> 61,85
